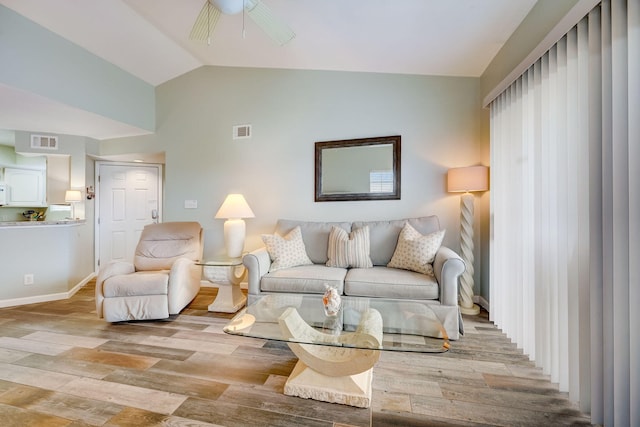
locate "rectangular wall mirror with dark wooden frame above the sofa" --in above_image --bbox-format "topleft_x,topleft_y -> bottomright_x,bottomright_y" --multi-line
315,135 -> 400,202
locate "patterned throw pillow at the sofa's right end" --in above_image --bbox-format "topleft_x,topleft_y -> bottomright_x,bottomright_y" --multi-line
387,223 -> 445,276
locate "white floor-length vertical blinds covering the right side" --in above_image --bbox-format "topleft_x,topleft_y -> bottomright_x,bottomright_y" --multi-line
490,0 -> 640,426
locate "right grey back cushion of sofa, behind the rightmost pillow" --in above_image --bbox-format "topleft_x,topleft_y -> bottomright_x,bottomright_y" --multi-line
352,215 -> 440,266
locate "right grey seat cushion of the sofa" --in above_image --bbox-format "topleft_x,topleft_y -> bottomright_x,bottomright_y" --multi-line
344,267 -> 440,300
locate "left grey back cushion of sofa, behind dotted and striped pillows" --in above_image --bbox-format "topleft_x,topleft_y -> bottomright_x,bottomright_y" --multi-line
275,219 -> 352,264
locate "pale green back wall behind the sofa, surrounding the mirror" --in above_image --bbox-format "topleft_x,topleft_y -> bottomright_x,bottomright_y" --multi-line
100,67 -> 487,289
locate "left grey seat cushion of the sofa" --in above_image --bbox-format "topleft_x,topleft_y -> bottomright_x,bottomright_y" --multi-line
260,264 -> 347,294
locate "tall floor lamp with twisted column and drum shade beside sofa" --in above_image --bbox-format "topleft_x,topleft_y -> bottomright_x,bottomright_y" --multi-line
447,166 -> 489,315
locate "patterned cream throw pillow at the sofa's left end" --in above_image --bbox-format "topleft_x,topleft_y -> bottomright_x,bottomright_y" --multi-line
261,226 -> 313,271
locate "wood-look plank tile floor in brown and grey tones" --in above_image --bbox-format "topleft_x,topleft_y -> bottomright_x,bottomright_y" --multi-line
0,283 -> 589,427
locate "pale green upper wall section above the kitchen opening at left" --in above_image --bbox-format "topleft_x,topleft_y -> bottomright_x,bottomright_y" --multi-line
0,5 -> 155,131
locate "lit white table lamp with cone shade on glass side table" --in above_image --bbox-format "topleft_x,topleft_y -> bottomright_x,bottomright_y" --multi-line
215,194 -> 255,258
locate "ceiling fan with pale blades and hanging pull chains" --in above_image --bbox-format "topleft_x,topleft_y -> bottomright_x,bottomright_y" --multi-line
189,0 -> 296,46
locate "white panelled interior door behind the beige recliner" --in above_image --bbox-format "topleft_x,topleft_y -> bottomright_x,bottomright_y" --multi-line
96,163 -> 162,268
